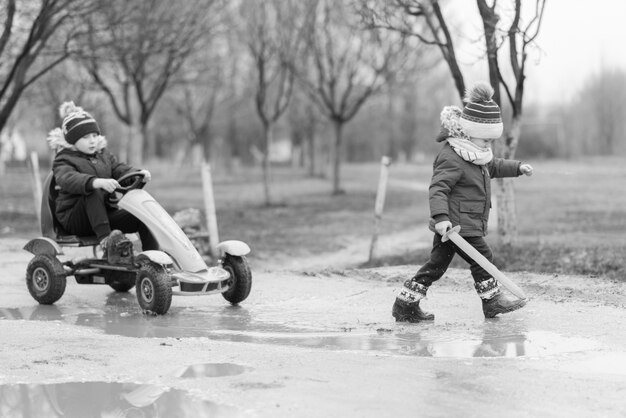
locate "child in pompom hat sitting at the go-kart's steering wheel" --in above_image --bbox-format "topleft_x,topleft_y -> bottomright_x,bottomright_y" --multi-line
47,102 -> 158,261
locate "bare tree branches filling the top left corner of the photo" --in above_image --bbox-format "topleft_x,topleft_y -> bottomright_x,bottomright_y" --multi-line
0,0 -> 99,131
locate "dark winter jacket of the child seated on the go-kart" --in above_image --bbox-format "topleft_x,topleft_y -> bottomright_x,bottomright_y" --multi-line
52,148 -> 134,225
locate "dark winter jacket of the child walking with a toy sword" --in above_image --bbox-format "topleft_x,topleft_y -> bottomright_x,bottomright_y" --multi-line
429,138 -> 521,237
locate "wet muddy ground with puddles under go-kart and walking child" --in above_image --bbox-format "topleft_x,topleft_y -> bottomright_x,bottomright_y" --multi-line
0,238 -> 626,417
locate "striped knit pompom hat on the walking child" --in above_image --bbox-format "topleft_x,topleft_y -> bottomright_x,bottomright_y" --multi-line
459,83 -> 504,139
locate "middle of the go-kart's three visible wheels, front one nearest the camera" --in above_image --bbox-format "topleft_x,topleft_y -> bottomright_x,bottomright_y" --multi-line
135,263 -> 172,315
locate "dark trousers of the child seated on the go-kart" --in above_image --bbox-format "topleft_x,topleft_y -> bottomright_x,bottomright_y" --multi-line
58,189 -> 159,251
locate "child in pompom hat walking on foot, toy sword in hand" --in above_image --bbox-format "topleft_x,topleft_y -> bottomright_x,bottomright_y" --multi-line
392,83 -> 533,322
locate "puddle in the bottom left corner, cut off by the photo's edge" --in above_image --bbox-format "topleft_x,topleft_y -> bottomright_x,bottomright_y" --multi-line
0,382 -> 243,418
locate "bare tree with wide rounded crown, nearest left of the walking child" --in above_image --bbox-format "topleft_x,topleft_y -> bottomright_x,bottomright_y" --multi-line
296,0 -> 404,195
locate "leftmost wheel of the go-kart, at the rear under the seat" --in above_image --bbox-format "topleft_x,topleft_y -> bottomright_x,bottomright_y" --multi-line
26,254 -> 67,305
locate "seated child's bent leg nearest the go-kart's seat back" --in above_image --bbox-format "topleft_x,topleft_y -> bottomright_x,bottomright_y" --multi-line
63,189 -> 111,240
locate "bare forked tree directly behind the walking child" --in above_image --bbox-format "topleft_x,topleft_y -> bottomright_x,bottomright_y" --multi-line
365,0 -> 545,244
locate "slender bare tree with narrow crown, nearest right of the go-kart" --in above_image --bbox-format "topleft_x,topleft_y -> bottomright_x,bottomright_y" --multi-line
240,0 -> 308,205
